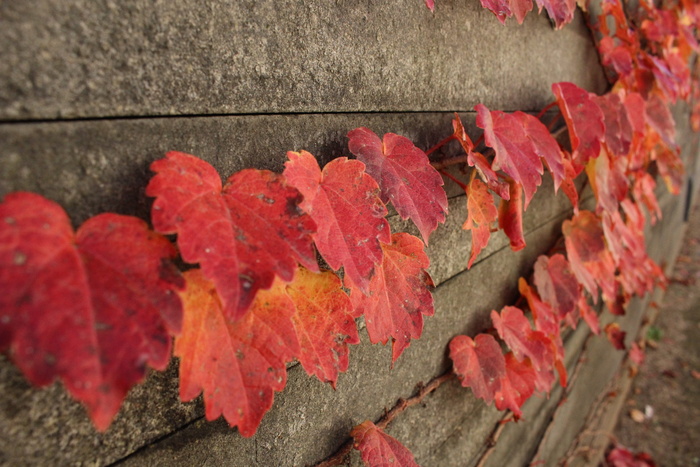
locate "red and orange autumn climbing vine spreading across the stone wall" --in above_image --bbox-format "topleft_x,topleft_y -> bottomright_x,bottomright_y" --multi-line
0,0 -> 700,465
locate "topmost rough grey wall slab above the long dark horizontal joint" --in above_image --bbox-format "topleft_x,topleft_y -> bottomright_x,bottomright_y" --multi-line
0,0 -> 605,120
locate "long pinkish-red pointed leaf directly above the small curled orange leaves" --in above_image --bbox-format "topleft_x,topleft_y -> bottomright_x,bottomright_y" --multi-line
474,104 -> 544,209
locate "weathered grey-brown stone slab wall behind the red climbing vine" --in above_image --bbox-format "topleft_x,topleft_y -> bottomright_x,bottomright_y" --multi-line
0,0 -> 698,466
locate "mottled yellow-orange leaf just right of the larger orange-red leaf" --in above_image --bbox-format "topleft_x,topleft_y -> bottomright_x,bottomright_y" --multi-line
286,268 -> 360,388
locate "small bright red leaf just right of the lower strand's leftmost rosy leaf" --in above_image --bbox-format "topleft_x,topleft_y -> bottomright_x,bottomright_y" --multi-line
494,352 -> 537,420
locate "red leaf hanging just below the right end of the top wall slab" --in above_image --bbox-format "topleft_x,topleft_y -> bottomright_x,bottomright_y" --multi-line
552,82 -> 605,166
